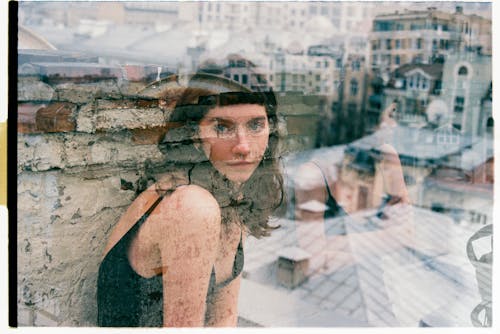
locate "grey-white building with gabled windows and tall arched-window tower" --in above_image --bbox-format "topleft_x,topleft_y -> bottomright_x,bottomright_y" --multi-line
383,52 -> 493,136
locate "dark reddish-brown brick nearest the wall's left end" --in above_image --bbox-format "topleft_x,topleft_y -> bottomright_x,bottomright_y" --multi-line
36,102 -> 76,132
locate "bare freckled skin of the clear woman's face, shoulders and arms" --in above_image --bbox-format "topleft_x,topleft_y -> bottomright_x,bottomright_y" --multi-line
99,104 -> 269,327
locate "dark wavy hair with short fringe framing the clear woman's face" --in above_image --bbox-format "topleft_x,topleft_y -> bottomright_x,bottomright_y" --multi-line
156,78 -> 286,237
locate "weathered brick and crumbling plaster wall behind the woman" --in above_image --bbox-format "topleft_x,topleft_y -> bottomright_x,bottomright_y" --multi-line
17,51 -> 317,326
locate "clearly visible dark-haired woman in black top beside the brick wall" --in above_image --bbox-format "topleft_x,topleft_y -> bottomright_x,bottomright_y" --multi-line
97,76 -> 283,327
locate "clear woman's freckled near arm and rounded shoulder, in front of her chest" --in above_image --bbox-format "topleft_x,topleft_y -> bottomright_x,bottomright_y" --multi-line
151,186 -> 221,327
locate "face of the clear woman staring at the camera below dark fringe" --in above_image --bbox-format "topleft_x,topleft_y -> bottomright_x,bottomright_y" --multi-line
199,104 -> 269,183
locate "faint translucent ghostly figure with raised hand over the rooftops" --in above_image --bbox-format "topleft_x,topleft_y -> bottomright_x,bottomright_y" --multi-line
294,103 -> 413,275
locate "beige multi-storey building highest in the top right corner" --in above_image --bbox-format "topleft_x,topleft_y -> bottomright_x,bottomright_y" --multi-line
370,6 -> 491,75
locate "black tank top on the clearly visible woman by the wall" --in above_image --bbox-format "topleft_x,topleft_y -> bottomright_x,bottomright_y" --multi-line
97,197 -> 244,327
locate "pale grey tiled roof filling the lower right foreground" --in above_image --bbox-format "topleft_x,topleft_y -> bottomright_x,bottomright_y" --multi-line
242,206 -> 480,326
